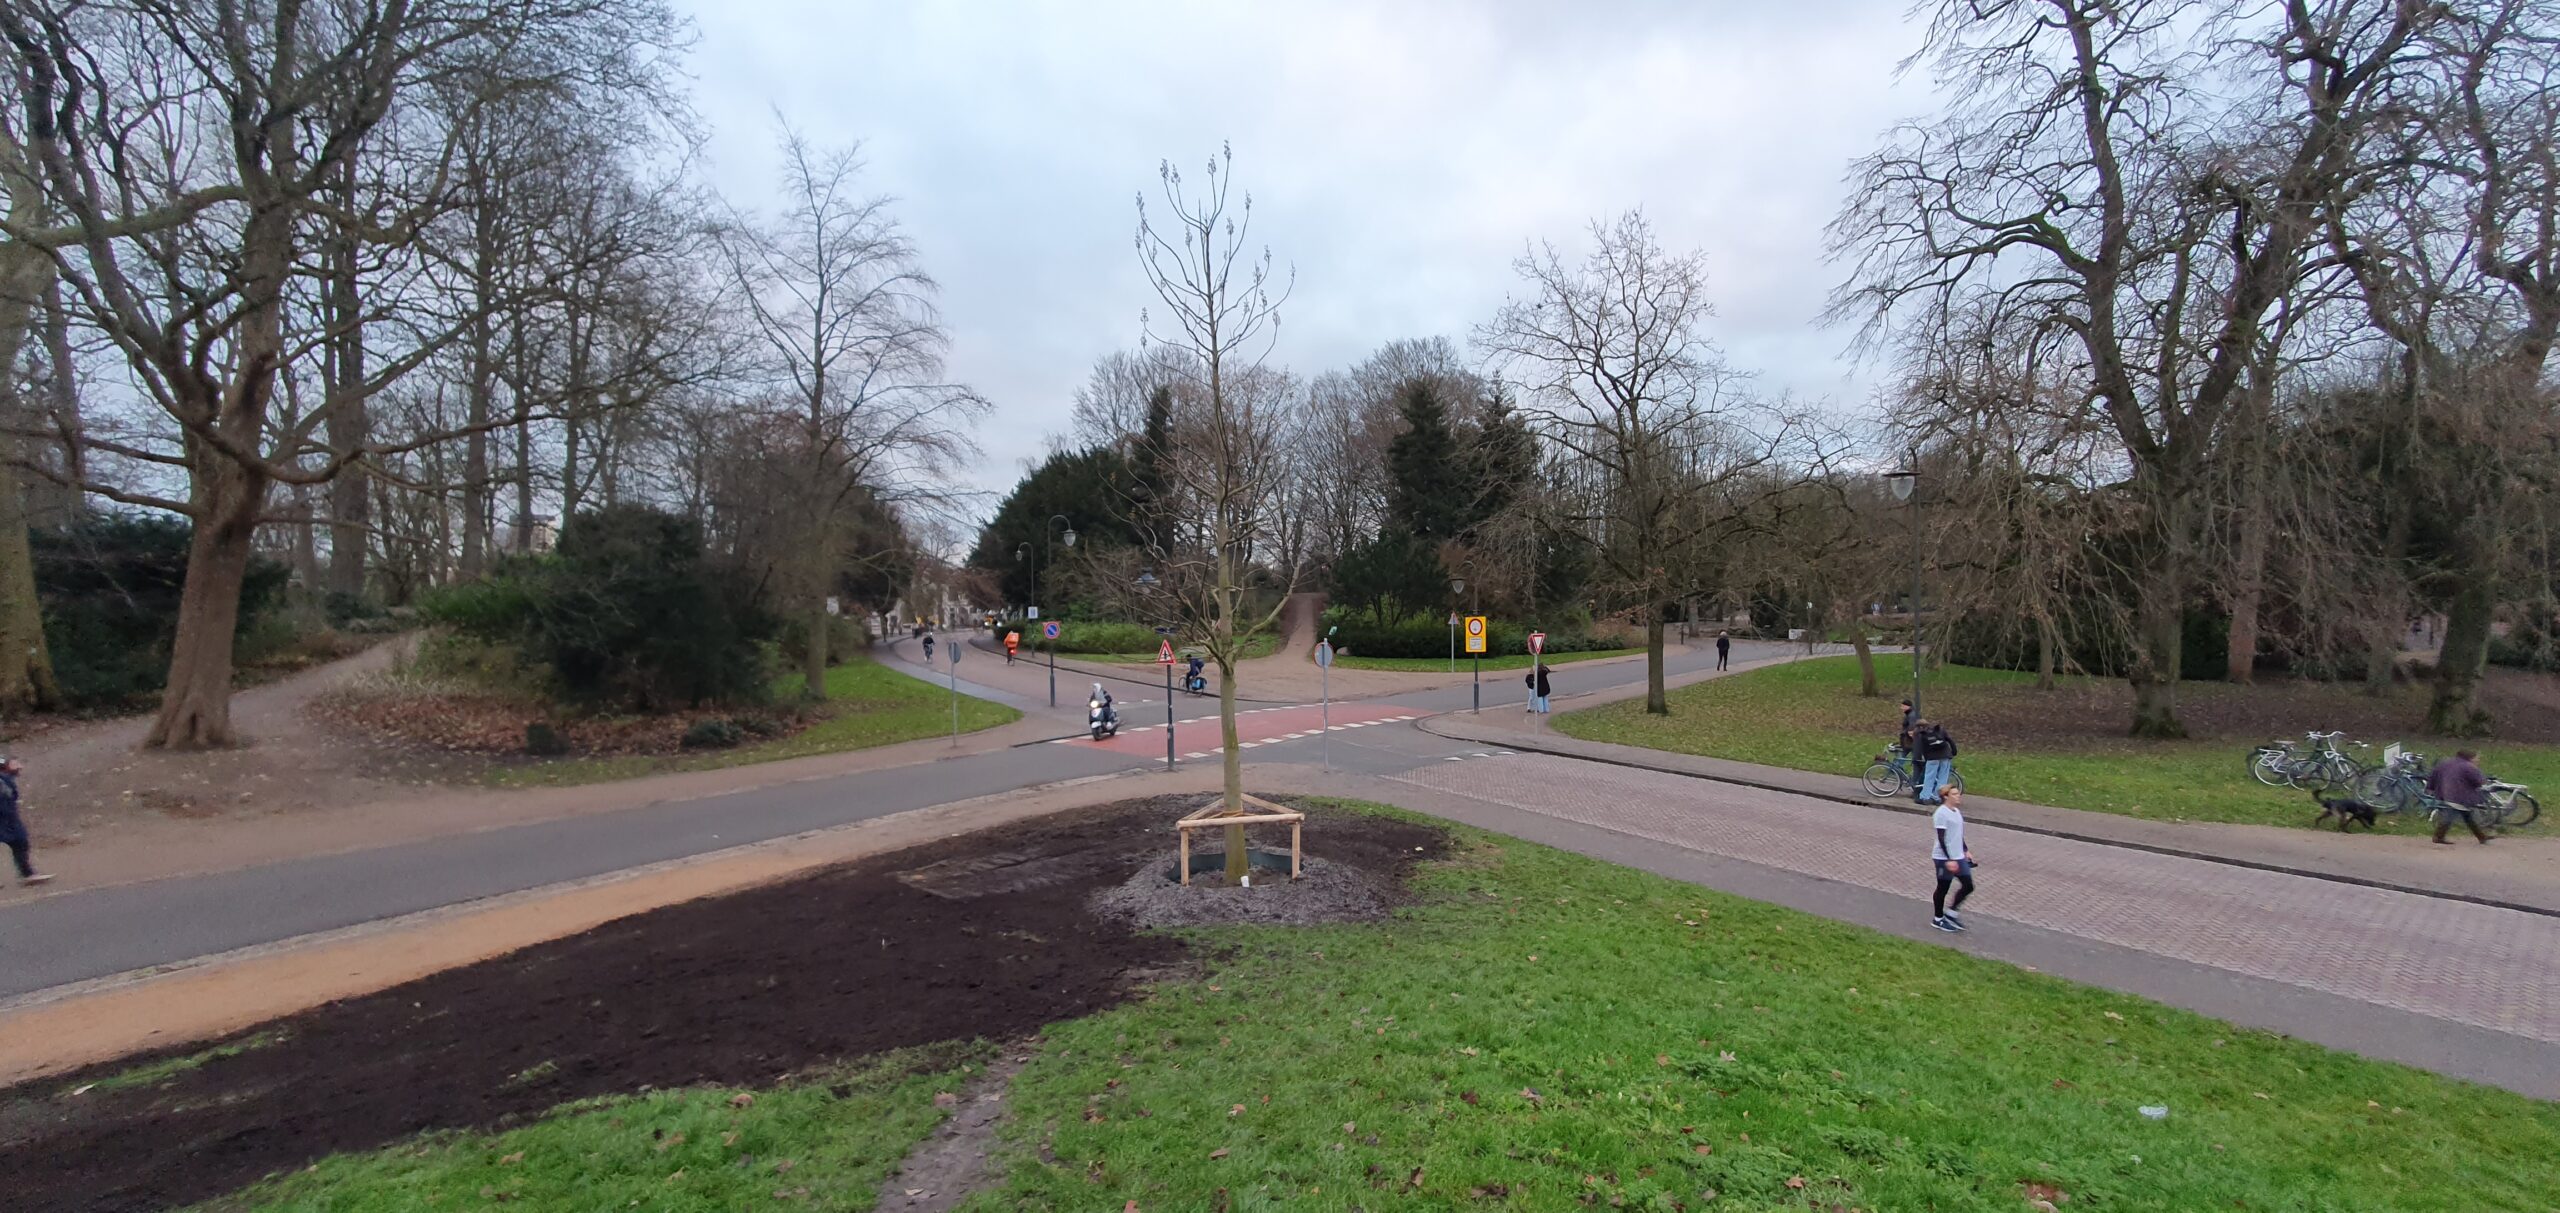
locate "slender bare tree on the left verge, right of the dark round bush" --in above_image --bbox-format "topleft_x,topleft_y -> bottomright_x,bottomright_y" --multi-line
727,131 -> 986,699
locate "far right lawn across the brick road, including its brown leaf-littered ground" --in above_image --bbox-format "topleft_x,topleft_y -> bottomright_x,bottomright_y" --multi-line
1554,655 -> 2560,832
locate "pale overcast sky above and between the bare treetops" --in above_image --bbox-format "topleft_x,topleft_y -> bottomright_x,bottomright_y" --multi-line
678,0 -> 1928,511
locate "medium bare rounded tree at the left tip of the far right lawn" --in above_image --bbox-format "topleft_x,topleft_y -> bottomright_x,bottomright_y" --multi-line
1475,210 -> 1820,714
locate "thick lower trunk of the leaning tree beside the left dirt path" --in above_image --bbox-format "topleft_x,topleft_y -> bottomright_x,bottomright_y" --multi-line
143,458 -> 266,750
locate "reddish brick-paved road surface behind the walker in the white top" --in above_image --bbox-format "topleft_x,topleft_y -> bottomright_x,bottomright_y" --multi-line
1398,755 -> 2560,1044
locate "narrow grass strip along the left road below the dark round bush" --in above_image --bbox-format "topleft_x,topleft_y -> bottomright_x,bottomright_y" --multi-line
489,655 -> 1021,788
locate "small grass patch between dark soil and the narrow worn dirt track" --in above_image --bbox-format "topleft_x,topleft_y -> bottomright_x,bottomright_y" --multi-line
220,1047 -> 988,1213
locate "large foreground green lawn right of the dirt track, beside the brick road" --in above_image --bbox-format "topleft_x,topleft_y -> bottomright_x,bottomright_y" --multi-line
965,798 -> 2560,1213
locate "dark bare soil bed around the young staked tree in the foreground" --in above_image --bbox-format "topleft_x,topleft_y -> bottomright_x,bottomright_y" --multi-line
0,796 -> 1446,1210
